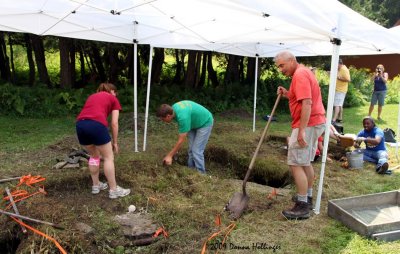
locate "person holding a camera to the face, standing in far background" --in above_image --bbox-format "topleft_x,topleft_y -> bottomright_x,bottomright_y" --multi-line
368,64 -> 389,120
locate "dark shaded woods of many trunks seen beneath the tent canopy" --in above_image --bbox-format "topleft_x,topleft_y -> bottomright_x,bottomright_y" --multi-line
0,32 -> 255,88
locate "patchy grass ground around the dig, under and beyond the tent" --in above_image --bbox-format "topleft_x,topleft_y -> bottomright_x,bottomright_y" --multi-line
0,105 -> 400,253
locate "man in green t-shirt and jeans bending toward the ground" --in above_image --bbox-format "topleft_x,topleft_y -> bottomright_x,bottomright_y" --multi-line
156,100 -> 214,173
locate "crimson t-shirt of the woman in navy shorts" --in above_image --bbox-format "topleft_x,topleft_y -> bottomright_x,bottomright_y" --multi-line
76,92 -> 122,127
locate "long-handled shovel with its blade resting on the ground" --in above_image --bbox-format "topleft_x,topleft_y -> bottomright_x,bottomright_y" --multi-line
225,94 -> 281,220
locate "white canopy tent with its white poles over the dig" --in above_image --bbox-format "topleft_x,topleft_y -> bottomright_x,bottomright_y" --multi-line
0,0 -> 400,214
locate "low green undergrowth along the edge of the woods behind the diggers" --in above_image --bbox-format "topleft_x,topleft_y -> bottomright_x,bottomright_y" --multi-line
0,64 -> 400,117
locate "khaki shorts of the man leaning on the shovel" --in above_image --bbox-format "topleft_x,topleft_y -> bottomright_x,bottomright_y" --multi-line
287,124 -> 325,166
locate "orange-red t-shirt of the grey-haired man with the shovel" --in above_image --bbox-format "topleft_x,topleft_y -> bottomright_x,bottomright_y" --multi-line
288,65 -> 325,129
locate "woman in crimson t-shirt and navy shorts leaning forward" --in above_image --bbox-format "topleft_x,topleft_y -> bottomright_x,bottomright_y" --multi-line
76,83 -> 131,199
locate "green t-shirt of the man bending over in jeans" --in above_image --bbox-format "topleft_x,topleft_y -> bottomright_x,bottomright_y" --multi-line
172,101 -> 213,133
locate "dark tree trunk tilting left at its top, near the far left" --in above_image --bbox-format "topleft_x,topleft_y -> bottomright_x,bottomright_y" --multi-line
30,34 -> 51,88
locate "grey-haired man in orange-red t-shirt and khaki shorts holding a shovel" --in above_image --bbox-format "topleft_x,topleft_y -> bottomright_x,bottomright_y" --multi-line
274,51 -> 326,219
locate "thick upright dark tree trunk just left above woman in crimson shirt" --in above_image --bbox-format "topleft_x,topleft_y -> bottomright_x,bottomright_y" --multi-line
58,37 -> 75,88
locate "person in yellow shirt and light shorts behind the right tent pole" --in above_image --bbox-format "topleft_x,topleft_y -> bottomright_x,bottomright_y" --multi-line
332,59 -> 350,123
